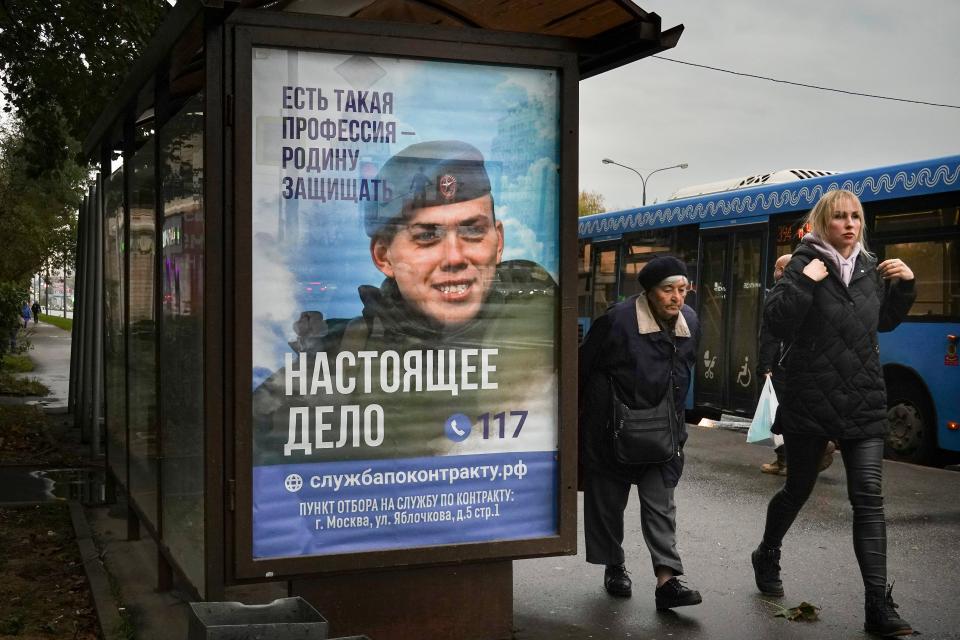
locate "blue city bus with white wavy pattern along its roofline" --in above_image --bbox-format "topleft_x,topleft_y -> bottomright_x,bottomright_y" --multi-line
578,155 -> 960,463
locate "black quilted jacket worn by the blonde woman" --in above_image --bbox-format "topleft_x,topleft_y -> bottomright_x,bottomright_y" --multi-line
763,243 -> 916,439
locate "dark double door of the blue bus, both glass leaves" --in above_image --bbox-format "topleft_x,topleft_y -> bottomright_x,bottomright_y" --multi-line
694,224 -> 766,416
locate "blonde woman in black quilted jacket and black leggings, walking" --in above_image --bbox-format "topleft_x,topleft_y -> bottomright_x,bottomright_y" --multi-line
752,190 -> 916,637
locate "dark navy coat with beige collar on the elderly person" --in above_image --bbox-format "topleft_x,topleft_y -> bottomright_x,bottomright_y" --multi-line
580,295 -> 700,487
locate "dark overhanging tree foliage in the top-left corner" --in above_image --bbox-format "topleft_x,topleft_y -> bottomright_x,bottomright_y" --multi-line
0,0 -> 170,176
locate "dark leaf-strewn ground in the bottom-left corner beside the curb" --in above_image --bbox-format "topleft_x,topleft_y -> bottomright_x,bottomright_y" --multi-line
0,502 -> 99,640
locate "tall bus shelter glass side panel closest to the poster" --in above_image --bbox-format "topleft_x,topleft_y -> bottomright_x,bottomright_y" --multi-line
158,96 -> 204,595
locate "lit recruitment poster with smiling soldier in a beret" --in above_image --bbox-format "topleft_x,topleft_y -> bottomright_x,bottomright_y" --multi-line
250,48 -> 560,559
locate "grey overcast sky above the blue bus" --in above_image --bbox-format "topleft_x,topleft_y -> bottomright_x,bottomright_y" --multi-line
580,0 -> 960,210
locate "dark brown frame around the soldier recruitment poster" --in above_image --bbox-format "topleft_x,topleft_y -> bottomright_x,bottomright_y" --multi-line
224,12 -> 579,582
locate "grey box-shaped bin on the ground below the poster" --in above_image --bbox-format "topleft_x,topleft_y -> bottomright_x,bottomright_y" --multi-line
187,597 -> 327,640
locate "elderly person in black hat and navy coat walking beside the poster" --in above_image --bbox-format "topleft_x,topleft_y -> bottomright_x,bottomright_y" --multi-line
580,256 -> 701,609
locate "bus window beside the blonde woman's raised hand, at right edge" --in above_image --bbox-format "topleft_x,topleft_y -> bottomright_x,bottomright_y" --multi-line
885,240 -> 960,318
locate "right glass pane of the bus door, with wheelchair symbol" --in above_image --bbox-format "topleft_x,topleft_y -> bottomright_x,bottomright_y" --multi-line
725,233 -> 763,413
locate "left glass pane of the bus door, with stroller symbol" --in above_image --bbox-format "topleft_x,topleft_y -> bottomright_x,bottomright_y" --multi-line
694,236 -> 727,409
